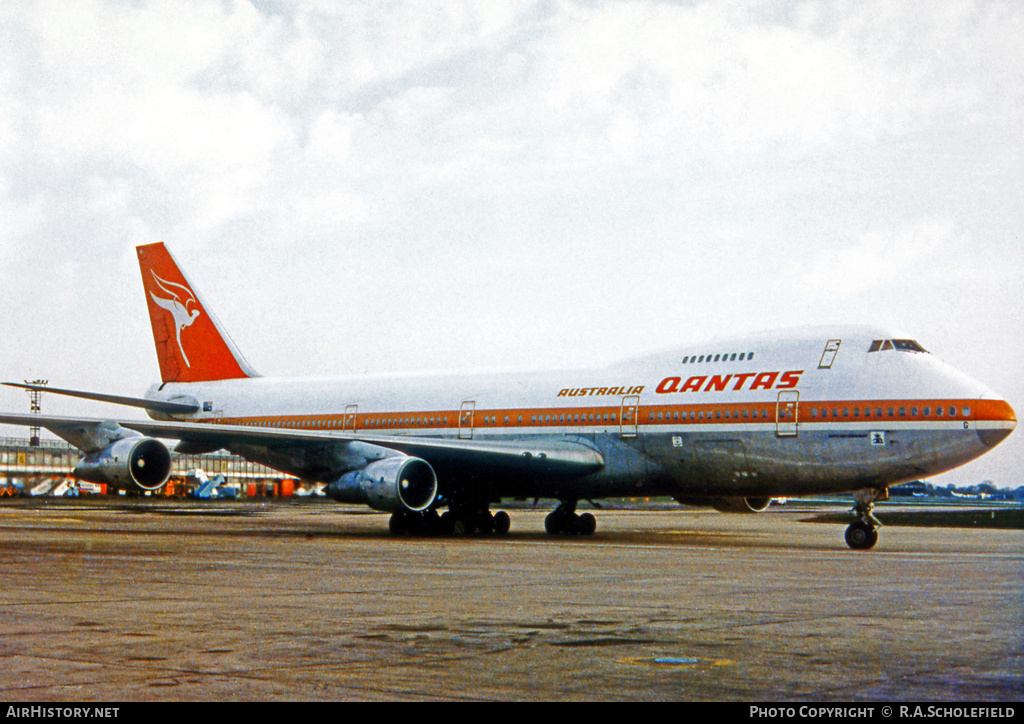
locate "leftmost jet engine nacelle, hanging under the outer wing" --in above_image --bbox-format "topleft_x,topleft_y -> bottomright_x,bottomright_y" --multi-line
75,437 -> 171,493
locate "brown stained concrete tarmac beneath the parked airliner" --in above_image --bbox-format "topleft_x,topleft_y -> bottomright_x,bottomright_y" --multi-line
0,498 -> 1024,702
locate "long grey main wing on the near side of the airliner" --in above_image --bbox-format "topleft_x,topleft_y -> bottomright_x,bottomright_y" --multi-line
0,414 -> 604,475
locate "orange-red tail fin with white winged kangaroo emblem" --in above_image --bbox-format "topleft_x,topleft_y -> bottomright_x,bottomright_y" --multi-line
136,242 -> 257,382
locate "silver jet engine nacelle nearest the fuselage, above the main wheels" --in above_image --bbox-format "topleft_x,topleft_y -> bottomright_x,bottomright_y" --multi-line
327,455 -> 437,513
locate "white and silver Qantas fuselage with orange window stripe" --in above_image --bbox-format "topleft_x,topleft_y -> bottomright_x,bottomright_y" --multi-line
147,328 -> 1016,499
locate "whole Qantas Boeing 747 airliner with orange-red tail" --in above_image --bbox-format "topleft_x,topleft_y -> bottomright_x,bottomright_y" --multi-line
0,243 -> 1017,549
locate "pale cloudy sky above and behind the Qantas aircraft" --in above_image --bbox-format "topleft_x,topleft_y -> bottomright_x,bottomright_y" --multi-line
0,0 -> 1024,486
